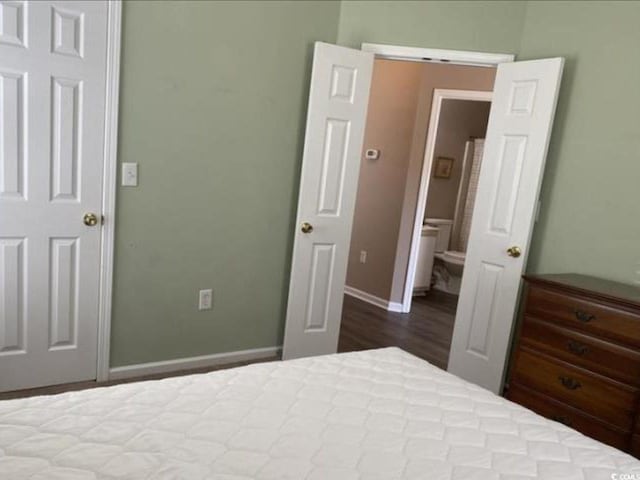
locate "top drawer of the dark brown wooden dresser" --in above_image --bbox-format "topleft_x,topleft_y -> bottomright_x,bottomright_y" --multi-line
525,285 -> 640,346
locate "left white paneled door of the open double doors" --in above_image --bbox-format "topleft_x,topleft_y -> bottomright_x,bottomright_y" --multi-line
282,42 -> 373,359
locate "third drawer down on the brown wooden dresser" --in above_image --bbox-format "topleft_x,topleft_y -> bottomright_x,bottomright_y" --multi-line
511,345 -> 638,430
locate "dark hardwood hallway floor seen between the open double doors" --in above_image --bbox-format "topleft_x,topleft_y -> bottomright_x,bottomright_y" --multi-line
338,290 -> 458,369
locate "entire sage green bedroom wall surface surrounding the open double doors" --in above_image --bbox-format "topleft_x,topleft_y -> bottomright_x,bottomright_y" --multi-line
111,1 -> 640,366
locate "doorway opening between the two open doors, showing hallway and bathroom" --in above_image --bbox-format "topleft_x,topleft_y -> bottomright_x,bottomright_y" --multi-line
338,58 -> 496,368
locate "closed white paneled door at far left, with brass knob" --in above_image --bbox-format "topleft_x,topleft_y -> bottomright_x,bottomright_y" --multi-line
0,1 -> 107,390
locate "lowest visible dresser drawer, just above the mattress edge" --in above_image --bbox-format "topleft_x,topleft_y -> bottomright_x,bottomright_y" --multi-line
507,382 -> 631,450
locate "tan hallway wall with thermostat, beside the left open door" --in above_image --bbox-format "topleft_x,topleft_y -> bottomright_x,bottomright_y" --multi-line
347,59 -> 422,299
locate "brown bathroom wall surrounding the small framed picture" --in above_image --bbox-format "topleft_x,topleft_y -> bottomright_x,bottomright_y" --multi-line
424,100 -> 491,223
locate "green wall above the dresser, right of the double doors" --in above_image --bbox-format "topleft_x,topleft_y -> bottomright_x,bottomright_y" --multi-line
519,2 -> 640,284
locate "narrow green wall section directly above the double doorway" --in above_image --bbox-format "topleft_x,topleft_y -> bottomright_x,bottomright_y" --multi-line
338,0 -> 526,53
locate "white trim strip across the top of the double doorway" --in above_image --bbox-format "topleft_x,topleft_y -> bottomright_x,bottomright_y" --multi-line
361,43 -> 516,67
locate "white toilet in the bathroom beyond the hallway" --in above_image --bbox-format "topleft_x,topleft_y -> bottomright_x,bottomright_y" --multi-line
424,218 -> 466,295
